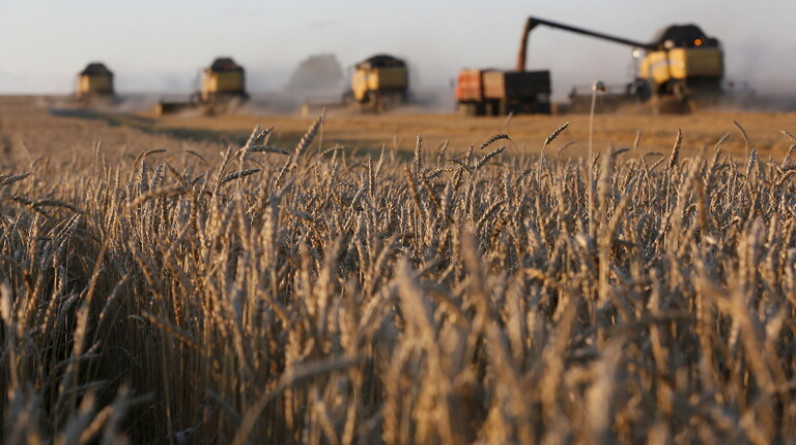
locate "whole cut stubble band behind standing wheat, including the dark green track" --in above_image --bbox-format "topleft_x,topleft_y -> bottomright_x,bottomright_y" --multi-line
0,96 -> 796,165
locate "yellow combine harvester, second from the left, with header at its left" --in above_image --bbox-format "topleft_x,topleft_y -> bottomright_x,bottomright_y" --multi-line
155,57 -> 249,115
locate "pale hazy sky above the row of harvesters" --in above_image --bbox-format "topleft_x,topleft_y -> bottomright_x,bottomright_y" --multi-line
0,0 -> 796,97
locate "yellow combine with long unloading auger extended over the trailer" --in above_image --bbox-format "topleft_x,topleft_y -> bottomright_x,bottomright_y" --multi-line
518,17 -> 724,113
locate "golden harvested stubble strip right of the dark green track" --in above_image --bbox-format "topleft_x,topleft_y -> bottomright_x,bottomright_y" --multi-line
137,103 -> 796,157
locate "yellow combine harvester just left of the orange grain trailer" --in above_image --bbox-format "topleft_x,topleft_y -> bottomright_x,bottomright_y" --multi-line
302,54 -> 409,115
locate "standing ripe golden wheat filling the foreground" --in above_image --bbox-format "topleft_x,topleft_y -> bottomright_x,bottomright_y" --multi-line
0,99 -> 796,444
